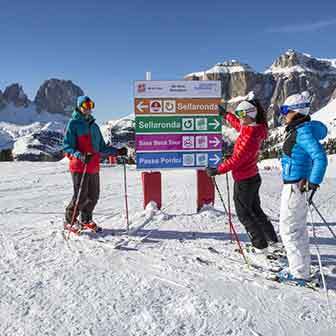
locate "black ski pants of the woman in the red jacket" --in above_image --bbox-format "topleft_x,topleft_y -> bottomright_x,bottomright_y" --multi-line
233,174 -> 278,249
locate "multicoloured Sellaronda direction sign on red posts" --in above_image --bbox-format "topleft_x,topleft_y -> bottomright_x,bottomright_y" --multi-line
134,80 -> 222,208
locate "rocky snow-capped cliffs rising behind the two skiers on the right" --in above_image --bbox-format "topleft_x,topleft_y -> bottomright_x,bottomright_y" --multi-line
185,49 -> 336,126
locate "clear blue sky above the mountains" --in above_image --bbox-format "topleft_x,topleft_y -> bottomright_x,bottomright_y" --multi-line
0,0 -> 336,122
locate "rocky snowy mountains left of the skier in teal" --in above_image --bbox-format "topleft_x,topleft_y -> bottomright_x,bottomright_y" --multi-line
0,79 -> 83,161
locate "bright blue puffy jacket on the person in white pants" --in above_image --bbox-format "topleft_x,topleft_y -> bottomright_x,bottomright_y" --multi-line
281,121 -> 328,184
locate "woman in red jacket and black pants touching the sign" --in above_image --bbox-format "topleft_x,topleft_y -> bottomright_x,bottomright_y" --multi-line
207,99 -> 278,250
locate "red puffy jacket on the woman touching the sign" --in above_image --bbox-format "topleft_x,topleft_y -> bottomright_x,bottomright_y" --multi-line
218,113 -> 268,181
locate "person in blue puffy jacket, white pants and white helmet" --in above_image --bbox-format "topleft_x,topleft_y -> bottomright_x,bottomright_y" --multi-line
280,94 -> 328,283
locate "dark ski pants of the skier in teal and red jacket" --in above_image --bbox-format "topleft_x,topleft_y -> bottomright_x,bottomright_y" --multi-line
65,173 -> 100,223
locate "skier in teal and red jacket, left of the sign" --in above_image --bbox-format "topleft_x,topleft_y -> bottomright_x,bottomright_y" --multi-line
63,96 -> 127,233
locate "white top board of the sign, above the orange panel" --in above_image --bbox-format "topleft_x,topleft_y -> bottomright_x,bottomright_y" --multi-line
134,81 -> 221,98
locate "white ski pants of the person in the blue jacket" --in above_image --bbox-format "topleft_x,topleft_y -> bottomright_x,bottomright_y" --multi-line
280,184 -> 311,279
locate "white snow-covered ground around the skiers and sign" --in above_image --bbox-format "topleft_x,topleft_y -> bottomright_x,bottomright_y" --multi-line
0,162 -> 336,336
